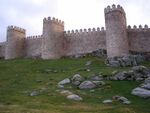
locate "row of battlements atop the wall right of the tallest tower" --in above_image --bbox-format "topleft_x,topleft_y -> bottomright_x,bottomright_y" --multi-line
127,24 -> 150,31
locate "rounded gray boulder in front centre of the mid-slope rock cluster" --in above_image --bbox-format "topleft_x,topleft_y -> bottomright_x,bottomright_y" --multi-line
79,80 -> 96,89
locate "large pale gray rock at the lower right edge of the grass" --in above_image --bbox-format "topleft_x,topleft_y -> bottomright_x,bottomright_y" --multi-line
131,87 -> 150,98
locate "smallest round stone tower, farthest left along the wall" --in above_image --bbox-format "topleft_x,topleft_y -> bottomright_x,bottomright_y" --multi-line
5,26 -> 26,59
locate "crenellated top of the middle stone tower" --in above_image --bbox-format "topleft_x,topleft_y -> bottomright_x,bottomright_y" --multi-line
43,17 -> 64,26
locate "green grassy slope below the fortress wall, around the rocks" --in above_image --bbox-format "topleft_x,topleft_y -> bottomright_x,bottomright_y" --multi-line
0,57 -> 150,113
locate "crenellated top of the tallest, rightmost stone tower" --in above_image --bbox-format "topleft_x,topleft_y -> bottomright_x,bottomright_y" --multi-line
104,4 -> 125,14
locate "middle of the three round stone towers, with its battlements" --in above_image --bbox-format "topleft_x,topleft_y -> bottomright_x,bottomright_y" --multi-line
42,17 -> 64,59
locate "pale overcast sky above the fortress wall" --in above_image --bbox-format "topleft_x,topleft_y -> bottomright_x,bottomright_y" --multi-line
0,0 -> 150,42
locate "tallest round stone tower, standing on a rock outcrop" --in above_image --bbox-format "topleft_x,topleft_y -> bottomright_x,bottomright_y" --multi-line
104,5 -> 129,57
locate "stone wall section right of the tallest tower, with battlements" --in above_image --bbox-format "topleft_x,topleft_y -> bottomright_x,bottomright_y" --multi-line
128,26 -> 150,52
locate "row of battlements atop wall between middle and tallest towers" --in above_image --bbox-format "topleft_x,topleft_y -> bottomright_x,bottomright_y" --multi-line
64,27 -> 105,35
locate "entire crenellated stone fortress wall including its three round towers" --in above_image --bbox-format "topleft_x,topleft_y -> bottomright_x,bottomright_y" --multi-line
0,5 -> 150,59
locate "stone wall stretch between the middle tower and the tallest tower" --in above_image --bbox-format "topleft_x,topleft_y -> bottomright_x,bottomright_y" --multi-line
64,28 -> 106,56
